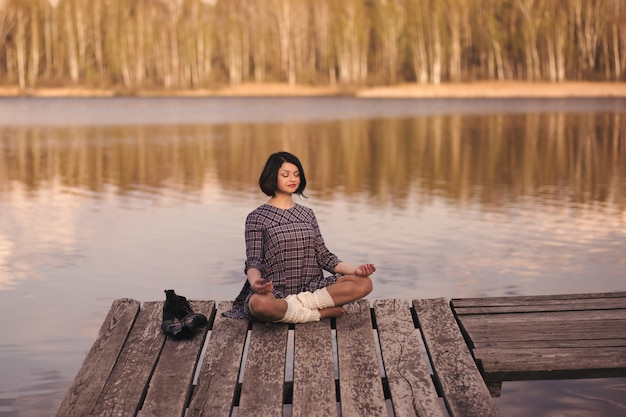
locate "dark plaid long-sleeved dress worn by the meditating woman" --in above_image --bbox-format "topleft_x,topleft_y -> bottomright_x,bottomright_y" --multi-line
224,204 -> 341,319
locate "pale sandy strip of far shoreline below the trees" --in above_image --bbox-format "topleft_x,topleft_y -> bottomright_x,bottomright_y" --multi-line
0,81 -> 626,98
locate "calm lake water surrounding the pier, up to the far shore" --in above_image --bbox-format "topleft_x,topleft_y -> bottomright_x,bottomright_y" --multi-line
0,98 -> 626,417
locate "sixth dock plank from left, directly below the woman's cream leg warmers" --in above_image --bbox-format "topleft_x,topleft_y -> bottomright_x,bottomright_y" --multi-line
292,319 -> 337,417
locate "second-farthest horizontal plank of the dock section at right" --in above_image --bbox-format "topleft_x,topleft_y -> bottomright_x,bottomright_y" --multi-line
459,309 -> 626,325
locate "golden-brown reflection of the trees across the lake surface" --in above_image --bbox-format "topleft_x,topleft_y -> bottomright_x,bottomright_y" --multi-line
0,113 -> 626,210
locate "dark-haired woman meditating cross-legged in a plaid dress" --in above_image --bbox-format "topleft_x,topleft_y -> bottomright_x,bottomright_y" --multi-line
224,152 -> 376,323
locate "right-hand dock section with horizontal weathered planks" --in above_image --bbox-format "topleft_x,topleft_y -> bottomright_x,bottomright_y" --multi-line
452,292 -> 626,382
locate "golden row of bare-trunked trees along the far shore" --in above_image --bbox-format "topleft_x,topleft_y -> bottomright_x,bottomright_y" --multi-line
0,0 -> 626,92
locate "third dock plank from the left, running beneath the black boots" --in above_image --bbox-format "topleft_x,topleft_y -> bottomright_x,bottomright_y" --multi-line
141,301 -> 215,417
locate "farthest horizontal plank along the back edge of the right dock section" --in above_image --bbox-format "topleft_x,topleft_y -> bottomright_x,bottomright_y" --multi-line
450,292 -> 626,311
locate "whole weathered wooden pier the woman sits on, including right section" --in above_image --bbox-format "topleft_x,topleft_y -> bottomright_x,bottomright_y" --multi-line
57,292 -> 626,417
